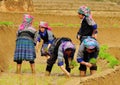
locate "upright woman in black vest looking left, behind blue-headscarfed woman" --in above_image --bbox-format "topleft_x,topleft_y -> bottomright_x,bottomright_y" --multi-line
77,6 -> 97,42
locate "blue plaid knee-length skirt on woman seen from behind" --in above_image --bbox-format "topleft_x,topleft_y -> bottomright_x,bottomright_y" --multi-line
14,38 -> 36,62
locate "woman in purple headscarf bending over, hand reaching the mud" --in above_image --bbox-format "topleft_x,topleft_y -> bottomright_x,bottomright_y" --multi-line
46,37 -> 75,77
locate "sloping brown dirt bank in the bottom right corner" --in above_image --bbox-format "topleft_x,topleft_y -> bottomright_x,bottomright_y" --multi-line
80,66 -> 120,85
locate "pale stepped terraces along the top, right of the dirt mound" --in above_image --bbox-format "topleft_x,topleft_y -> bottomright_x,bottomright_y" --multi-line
33,0 -> 120,15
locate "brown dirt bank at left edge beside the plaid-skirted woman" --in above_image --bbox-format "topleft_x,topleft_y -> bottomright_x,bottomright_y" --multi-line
0,26 -> 15,71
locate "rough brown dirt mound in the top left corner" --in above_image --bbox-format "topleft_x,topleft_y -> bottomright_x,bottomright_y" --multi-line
0,0 -> 34,12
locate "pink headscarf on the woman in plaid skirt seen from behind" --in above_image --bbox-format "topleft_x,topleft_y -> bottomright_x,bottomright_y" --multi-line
19,14 -> 33,30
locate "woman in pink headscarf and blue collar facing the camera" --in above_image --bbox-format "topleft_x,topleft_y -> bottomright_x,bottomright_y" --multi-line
37,21 -> 55,57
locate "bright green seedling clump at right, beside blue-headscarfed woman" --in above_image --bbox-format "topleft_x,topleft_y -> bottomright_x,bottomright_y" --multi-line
99,45 -> 120,68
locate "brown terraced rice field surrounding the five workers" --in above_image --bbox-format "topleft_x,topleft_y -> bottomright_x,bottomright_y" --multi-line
0,0 -> 120,85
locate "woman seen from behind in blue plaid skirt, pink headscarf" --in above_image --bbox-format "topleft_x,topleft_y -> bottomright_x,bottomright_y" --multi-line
14,14 -> 37,73
